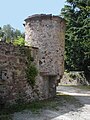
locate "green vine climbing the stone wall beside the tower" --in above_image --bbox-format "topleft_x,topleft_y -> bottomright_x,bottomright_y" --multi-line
26,49 -> 38,87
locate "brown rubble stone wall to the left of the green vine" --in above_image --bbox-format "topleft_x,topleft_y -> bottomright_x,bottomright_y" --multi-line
0,42 -> 31,105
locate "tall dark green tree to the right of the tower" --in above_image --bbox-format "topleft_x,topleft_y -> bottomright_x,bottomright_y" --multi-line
61,0 -> 90,70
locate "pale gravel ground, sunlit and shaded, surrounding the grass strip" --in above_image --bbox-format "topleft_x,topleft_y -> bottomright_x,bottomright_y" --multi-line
13,86 -> 90,120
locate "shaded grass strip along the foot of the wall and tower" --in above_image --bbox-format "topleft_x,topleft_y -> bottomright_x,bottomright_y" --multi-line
0,93 -> 81,120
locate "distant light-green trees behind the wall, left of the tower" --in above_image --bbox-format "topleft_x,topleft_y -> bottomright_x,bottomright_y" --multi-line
0,24 -> 25,45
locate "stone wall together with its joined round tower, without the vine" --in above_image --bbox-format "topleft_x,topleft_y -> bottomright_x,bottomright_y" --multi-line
0,14 -> 65,104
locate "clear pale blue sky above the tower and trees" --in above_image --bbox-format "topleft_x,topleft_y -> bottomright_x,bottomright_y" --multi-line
0,0 -> 65,31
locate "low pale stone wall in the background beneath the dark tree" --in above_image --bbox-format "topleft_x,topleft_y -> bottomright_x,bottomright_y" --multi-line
59,71 -> 90,85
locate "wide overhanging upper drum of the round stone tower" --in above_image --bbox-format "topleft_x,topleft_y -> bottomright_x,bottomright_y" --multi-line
25,14 -> 65,86
